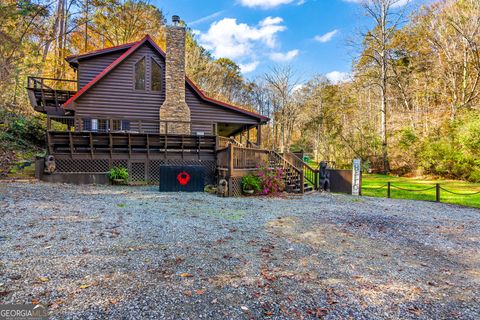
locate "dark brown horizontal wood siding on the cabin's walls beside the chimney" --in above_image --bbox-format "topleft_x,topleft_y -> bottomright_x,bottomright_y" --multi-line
76,44 -> 258,135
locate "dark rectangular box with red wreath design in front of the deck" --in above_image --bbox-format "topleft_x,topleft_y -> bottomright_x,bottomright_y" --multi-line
159,165 -> 205,192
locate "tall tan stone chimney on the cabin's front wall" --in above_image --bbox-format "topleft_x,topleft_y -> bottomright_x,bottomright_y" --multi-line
160,16 -> 190,134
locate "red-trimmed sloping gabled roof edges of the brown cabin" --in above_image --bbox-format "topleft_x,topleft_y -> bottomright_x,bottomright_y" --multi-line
63,35 -> 270,122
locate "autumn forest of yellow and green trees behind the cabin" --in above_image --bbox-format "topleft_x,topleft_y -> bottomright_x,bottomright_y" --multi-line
0,0 -> 480,181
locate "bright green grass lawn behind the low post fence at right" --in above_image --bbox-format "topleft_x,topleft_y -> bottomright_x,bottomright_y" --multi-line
362,174 -> 480,208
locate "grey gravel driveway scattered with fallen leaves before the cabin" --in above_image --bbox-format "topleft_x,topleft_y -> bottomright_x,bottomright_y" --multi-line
0,182 -> 480,319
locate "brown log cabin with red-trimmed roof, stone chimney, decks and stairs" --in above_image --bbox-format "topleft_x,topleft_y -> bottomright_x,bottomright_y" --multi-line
27,16 -> 317,195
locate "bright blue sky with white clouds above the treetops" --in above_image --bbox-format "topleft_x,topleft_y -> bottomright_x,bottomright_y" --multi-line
152,0 -> 426,81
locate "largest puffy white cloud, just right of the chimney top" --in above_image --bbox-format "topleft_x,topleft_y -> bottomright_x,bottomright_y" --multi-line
199,17 -> 286,59
